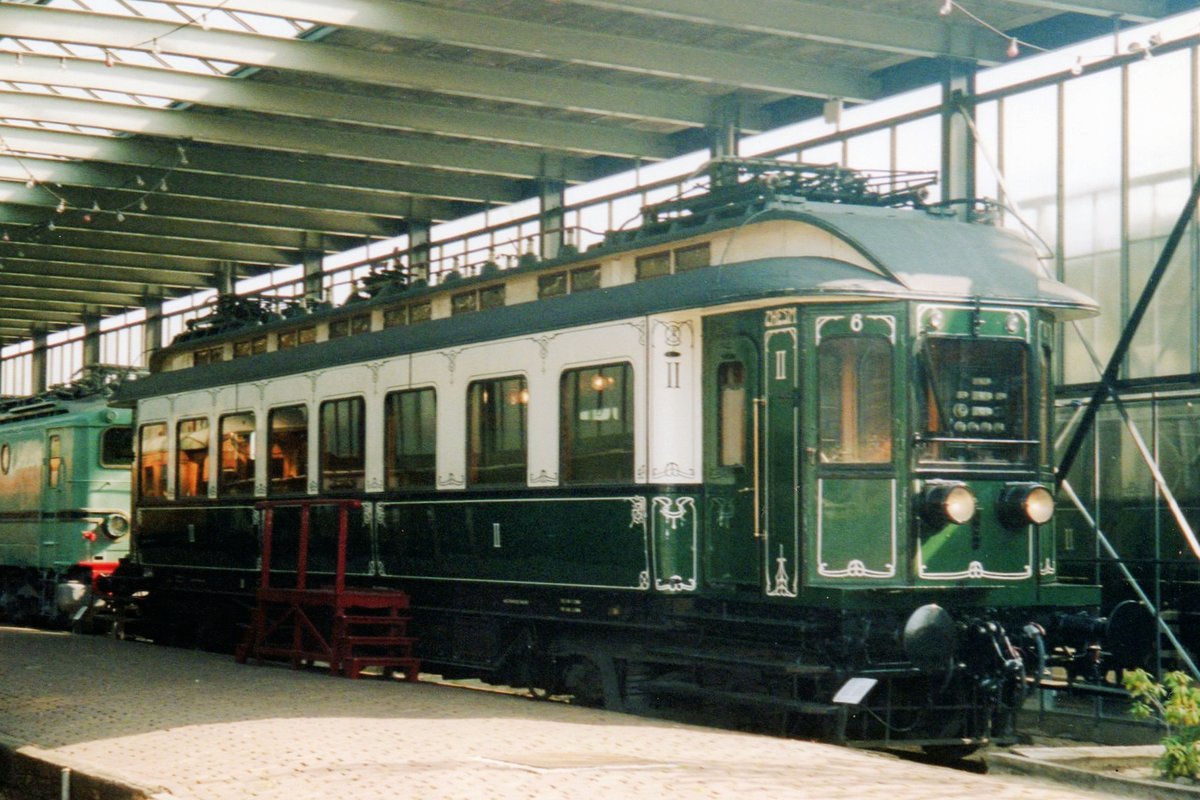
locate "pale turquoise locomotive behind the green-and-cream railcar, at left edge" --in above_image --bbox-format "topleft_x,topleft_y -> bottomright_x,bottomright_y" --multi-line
0,371 -> 133,622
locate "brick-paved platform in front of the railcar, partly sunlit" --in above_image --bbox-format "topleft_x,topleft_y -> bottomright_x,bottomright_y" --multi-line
0,627 -> 1123,800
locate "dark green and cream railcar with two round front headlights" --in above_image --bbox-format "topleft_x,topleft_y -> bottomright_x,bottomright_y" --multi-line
108,163 -> 1133,746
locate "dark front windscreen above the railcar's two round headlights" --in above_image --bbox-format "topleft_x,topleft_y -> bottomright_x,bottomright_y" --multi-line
917,336 -> 1030,463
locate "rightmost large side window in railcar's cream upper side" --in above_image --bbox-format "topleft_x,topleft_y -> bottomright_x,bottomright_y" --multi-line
559,363 -> 634,483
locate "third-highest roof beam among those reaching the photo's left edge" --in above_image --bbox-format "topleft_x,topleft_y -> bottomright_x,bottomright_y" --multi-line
0,92 -> 592,181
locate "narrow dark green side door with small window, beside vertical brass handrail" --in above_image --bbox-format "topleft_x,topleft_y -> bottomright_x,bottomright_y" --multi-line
703,314 -> 762,591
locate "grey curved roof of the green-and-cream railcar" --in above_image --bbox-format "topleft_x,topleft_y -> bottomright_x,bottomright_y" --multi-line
115,209 -> 1094,404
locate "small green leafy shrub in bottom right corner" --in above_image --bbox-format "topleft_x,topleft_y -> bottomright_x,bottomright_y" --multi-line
1124,669 -> 1200,780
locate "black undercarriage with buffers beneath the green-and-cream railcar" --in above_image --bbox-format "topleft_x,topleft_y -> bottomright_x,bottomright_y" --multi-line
100,561 -> 1138,756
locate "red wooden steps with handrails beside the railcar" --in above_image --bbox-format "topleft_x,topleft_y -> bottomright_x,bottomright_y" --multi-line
235,500 -> 421,680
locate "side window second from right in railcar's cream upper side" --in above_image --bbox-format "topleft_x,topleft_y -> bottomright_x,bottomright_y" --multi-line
467,375 -> 529,486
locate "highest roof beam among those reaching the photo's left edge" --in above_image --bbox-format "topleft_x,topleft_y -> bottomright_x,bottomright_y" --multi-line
0,2 -> 739,126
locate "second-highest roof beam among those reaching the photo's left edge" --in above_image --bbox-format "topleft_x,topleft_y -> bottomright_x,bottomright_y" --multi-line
0,55 -> 677,158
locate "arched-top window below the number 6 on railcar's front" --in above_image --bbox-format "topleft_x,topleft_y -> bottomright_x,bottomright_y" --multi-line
817,336 -> 894,464
